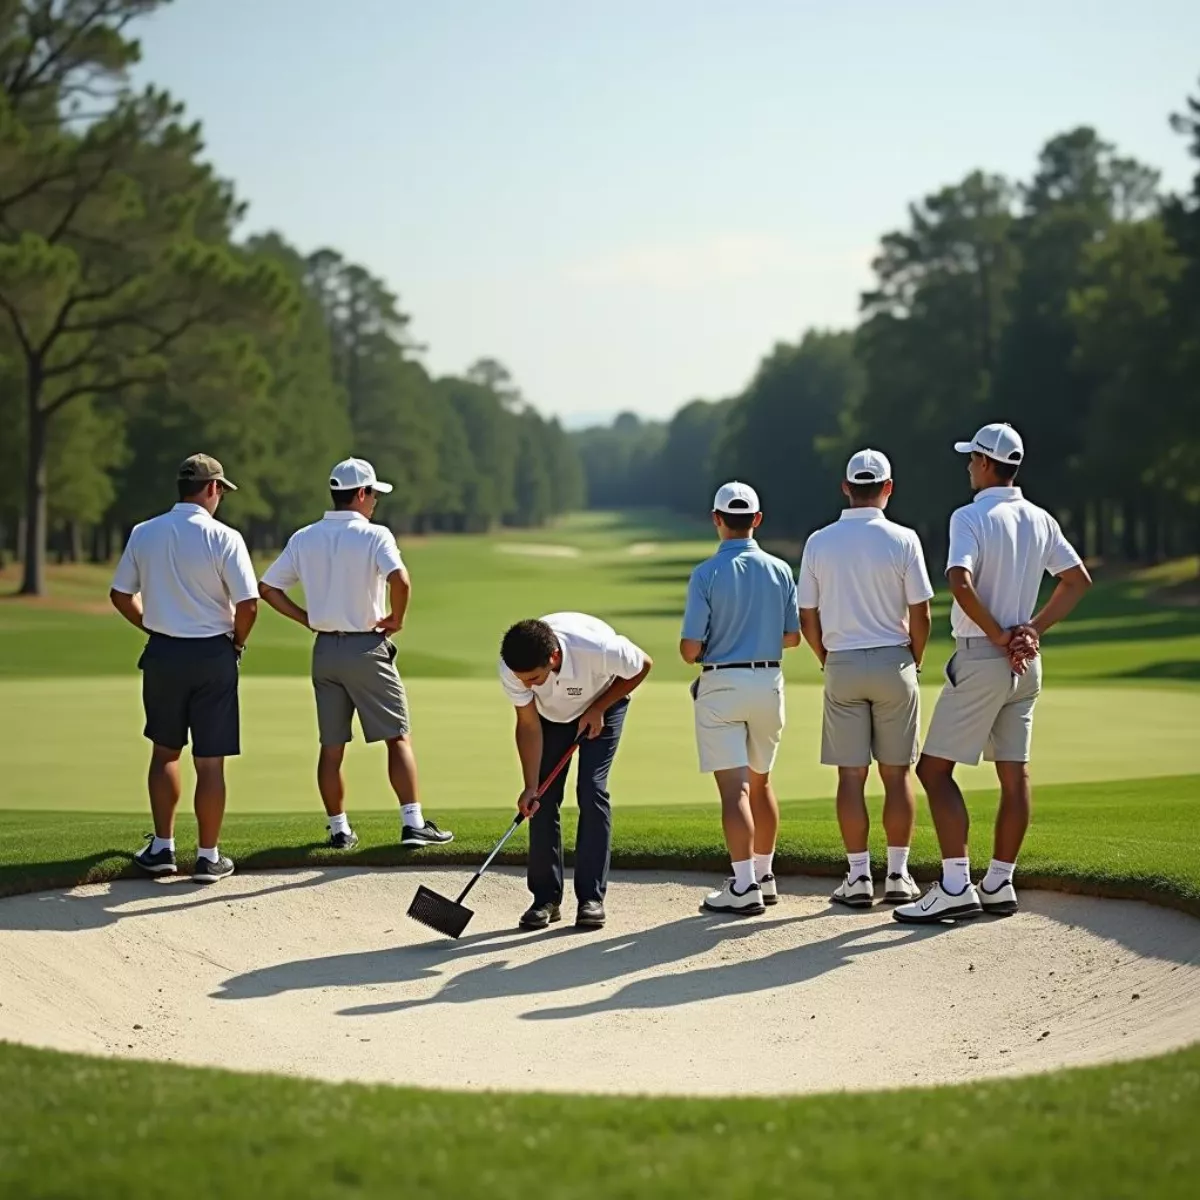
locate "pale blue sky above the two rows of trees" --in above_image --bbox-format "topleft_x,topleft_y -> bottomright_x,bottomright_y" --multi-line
133,0 -> 1200,424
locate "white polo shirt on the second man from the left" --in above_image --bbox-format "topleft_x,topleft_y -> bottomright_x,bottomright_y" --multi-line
263,511 -> 404,634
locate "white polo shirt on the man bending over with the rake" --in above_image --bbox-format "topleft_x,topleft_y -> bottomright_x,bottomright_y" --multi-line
500,612 -> 646,724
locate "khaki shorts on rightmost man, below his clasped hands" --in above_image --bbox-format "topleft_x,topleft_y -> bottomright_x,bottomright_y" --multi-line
923,637 -> 1042,767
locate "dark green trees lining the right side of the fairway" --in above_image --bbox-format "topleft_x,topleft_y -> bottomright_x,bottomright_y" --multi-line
574,88 -> 1200,562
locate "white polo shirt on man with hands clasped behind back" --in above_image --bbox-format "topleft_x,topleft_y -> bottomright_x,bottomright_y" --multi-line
946,487 -> 1082,637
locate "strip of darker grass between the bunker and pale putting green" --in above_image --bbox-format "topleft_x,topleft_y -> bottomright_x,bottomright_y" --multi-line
0,775 -> 1200,914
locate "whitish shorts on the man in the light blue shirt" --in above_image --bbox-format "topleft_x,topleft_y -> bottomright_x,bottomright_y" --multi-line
691,667 -> 784,775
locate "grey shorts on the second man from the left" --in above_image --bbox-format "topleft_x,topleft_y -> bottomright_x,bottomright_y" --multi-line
312,634 -> 408,746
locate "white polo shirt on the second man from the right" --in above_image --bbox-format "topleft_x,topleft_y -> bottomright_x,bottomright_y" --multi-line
798,508 -> 934,650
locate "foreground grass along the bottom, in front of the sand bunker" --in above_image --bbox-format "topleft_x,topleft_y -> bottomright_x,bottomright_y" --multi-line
0,1041 -> 1200,1200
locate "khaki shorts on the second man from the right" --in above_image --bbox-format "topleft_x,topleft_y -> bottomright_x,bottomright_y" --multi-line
821,646 -> 920,767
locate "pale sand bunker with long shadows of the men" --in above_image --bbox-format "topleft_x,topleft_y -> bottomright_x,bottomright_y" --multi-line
0,869 -> 1200,1094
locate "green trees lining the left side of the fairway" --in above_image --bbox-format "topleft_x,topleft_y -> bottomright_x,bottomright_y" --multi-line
0,0 -> 583,594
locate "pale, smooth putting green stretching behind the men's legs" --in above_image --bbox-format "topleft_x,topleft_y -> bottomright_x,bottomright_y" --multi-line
0,677 -> 1200,815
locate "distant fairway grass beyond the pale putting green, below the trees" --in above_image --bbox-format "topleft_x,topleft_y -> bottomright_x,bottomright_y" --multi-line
0,514 -> 1200,683
